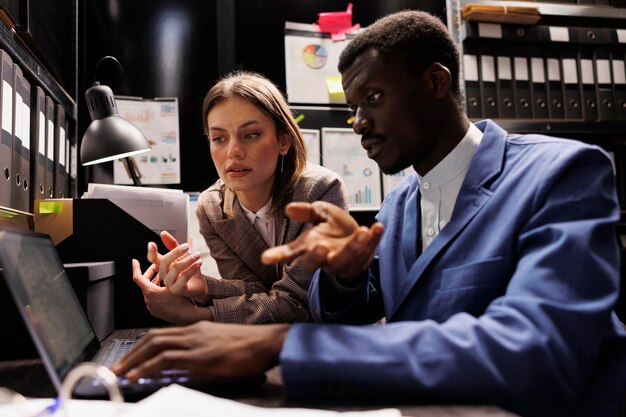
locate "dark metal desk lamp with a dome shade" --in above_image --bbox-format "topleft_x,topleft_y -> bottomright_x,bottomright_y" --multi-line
80,56 -> 150,186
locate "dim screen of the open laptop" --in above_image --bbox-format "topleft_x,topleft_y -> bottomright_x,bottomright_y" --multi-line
0,229 -> 98,389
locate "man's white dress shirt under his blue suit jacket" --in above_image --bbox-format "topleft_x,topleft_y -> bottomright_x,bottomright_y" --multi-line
417,123 -> 483,251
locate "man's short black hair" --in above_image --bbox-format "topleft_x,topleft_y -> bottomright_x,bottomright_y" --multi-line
338,10 -> 463,104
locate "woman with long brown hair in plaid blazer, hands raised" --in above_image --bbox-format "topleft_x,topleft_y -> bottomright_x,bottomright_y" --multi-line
133,72 -> 347,324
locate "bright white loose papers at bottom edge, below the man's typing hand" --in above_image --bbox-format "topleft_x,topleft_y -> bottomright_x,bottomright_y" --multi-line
123,385 -> 401,417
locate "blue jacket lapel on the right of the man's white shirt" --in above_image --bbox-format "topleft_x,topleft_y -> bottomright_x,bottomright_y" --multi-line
389,121 -> 506,316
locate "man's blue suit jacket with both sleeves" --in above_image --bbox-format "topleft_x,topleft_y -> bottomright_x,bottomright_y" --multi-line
281,121 -> 626,416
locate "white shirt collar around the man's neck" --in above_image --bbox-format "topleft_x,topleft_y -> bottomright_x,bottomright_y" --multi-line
417,123 -> 483,189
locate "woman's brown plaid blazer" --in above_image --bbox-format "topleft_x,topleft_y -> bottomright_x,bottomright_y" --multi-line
196,164 -> 348,323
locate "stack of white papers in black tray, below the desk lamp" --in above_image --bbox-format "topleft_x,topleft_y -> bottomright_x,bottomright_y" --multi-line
83,183 -> 189,243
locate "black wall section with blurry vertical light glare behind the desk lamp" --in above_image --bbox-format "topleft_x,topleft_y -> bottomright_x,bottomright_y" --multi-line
78,0 -> 217,191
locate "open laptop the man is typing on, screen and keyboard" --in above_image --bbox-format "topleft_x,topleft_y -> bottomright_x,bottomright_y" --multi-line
0,225 -> 265,401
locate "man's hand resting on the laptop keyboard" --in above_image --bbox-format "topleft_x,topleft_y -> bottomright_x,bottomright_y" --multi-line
112,321 -> 289,380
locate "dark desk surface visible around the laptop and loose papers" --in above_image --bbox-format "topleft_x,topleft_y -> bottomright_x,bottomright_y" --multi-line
0,329 -> 516,417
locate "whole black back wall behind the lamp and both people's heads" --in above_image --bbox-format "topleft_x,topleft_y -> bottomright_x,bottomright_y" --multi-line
78,0 -> 445,193
